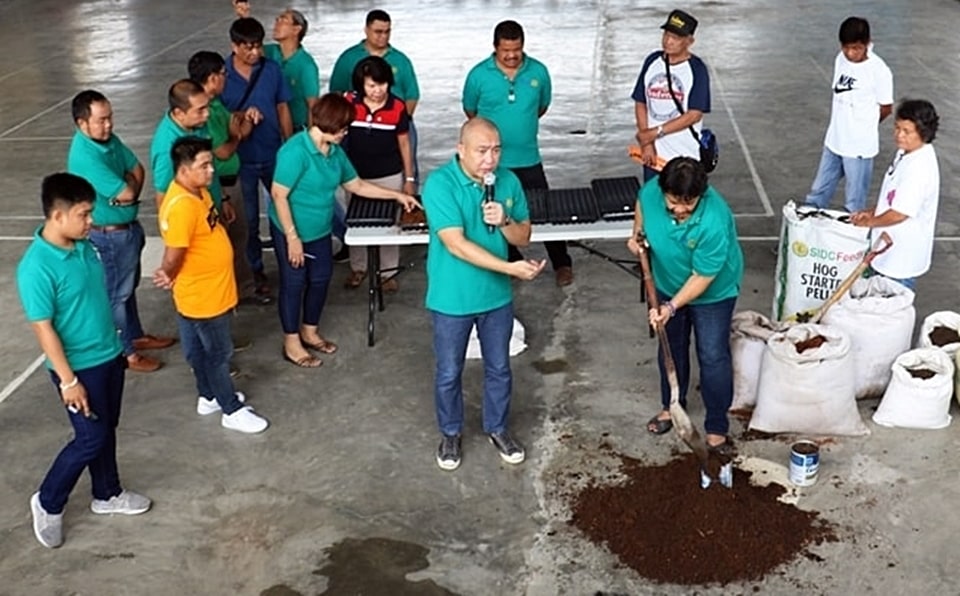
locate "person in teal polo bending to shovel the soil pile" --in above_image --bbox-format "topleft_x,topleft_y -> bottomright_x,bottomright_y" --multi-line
627,157 -> 743,454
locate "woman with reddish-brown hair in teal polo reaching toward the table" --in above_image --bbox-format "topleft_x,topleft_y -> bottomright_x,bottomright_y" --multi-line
268,93 -> 418,368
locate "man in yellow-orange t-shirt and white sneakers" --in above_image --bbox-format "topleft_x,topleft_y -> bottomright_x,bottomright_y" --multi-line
153,136 -> 267,433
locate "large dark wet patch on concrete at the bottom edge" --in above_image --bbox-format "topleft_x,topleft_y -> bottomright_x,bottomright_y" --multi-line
312,538 -> 455,596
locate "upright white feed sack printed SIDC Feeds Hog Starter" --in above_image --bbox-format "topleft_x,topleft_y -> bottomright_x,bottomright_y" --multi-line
773,201 -> 870,321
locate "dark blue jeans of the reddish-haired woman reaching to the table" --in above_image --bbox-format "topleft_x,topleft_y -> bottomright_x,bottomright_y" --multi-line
270,223 -> 333,335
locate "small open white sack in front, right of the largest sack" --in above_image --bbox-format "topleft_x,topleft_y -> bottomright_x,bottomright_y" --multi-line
873,348 -> 954,429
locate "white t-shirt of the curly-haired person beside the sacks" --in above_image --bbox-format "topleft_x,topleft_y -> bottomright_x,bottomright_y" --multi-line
873,143 -> 940,279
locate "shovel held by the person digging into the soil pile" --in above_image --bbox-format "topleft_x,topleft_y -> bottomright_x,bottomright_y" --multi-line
637,234 -> 733,488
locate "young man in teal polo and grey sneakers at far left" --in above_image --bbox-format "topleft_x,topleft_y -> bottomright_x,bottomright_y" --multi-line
17,174 -> 151,548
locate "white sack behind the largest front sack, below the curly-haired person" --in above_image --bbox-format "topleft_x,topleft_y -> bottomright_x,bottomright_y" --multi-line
823,275 -> 917,399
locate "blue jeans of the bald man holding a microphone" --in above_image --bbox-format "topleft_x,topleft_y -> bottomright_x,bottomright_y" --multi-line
431,303 -> 513,436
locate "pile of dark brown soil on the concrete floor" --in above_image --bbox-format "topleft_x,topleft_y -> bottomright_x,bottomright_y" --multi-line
569,454 -> 837,585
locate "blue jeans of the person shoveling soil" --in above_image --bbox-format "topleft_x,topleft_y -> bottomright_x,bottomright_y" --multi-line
657,290 -> 737,435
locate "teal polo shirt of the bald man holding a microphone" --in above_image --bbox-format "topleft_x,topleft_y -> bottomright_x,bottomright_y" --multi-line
422,157 -> 530,316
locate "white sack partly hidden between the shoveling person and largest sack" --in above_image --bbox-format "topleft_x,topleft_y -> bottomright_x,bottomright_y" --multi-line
730,310 -> 776,410
